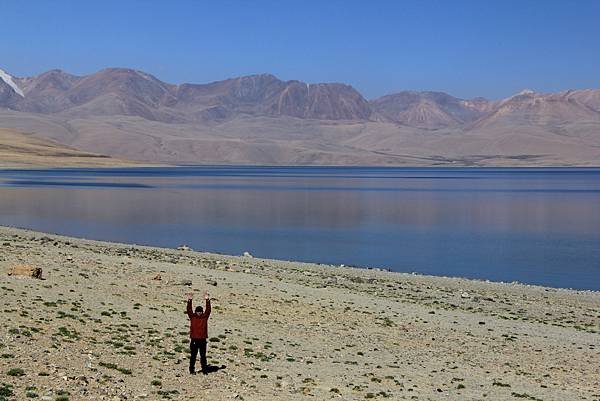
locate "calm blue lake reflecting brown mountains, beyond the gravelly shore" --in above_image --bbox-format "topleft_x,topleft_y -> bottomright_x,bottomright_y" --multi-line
0,167 -> 600,290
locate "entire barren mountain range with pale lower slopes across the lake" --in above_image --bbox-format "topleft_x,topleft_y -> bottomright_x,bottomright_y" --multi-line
0,68 -> 600,166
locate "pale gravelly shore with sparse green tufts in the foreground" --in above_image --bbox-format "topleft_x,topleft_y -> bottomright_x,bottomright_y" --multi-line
0,228 -> 600,401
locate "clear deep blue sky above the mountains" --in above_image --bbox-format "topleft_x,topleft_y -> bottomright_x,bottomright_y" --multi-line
0,0 -> 600,98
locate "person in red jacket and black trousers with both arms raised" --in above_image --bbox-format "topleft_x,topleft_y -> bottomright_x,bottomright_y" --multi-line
187,292 -> 210,375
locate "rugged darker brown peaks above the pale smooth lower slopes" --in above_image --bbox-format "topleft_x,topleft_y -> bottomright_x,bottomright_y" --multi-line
0,68 -> 600,129
